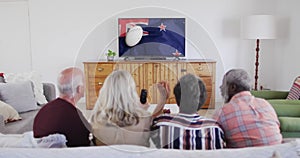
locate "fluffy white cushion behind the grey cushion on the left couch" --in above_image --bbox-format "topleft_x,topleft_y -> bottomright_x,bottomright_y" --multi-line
4,71 -> 47,105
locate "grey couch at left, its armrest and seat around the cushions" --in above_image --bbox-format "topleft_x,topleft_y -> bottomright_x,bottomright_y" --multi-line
0,83 -> 56,134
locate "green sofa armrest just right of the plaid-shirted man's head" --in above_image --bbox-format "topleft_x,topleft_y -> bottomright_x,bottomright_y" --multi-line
251,90 -> 289,100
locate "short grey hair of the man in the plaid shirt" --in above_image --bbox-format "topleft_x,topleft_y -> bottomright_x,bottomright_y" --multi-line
225,69 -> 251,91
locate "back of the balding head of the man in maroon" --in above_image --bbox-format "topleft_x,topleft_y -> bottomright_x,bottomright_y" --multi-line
57,67 -> 84,98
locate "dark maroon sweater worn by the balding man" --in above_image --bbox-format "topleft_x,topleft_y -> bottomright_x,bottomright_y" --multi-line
33,98 -> 91,147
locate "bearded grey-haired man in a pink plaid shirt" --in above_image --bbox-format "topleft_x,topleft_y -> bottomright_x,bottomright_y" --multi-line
213,69 -> 282,148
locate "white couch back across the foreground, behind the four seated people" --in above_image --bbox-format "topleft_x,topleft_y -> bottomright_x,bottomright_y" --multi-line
0,139 -> 300,158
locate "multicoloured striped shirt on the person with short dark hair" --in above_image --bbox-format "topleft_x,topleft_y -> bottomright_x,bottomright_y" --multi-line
154,114 -> 224,150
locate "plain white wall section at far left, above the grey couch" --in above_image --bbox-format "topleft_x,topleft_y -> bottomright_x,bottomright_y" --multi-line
0,2 -> 31,72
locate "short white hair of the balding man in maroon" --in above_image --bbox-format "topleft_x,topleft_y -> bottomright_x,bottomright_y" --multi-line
57,73 -> 83,97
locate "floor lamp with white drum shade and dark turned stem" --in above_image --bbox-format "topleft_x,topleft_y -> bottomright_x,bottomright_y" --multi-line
241,15 -> 276,90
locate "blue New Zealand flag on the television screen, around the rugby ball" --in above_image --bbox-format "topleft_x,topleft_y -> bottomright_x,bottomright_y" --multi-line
118,18 -> 185,57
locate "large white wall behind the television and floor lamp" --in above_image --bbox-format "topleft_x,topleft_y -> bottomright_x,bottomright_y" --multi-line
0,0 -> 299,100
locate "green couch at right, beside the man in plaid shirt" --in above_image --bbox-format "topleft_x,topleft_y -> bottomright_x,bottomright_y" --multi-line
251,90 -> 300,138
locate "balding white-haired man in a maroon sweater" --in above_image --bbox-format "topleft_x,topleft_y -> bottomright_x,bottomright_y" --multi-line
33,67 -> 90,147
